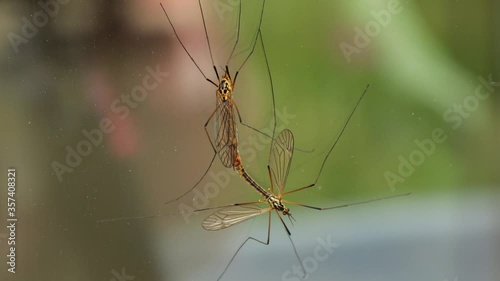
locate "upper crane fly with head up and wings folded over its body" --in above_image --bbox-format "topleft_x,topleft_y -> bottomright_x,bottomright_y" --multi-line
160,0 -> 276,204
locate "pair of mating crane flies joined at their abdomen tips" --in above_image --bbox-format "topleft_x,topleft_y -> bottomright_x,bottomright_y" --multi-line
99,0 -> 410,280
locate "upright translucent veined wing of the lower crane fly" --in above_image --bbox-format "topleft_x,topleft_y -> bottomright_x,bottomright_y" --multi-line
269,129 -> 293,197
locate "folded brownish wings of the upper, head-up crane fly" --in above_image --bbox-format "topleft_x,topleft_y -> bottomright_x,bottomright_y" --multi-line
215,99 -> 237,168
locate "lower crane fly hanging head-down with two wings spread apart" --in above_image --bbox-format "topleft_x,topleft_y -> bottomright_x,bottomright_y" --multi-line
98,86 -> 411,281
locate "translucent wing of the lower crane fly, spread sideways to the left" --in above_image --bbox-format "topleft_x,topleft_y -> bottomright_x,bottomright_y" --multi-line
201,205 -> 272,231
